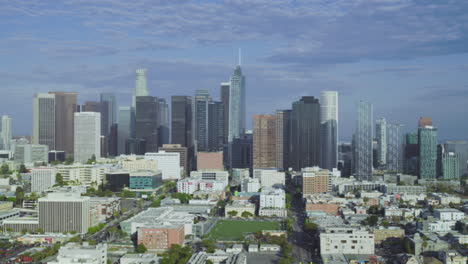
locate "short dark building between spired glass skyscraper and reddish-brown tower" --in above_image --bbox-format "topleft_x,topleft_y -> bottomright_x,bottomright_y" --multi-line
228,131 -> 253,169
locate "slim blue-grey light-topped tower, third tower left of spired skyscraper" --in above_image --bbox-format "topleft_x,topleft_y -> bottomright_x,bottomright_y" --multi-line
194,90 -> 211,151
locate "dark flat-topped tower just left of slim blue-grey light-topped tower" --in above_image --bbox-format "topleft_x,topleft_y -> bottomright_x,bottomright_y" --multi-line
171,96 -> 193,147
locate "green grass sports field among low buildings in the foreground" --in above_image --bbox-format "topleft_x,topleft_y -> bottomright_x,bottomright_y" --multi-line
209,220 -> 282,240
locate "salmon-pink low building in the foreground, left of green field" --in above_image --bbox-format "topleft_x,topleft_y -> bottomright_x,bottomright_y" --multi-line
138,224 -> 185,251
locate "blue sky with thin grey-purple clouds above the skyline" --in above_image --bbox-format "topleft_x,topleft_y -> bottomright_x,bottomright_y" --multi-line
0,0 -> 468,140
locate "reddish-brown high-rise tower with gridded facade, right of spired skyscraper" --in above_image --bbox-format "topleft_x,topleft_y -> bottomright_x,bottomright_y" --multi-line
253,115 -> 276,169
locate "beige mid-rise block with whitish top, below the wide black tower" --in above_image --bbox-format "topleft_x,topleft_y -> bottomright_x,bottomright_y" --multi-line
302,167 -> 331,196
